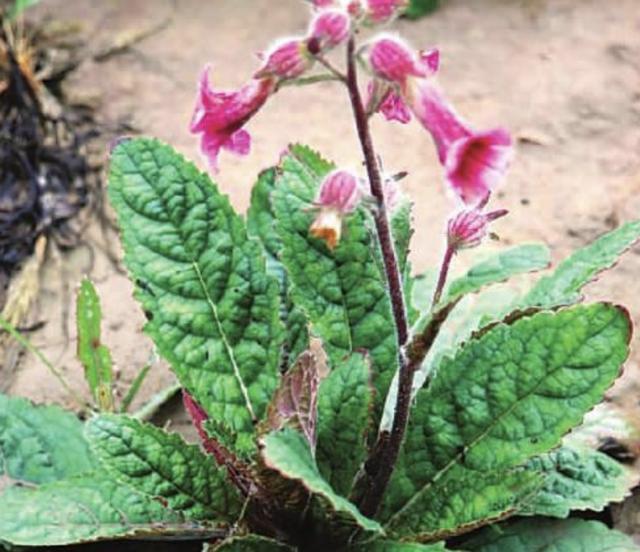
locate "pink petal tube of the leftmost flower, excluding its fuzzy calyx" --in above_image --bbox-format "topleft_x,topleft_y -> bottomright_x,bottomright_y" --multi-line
190,66 -> 276,171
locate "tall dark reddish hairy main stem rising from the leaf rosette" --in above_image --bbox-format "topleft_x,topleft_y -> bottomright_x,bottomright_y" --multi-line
346,37 -> 414,517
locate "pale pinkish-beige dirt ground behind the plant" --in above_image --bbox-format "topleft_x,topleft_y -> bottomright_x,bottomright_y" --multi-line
5,0 -> 640,486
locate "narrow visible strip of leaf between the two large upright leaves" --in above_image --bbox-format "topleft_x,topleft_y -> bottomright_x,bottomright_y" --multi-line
247,168 -> 309,369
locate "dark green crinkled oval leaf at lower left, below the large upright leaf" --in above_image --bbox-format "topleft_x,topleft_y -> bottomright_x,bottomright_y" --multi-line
86,414 -> 241,521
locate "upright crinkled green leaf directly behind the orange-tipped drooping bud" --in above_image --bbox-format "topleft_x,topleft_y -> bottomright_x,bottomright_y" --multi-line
273,146 -> 398,418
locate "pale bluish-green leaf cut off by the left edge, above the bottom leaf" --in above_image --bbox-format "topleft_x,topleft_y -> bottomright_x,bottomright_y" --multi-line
0,394 -> 94,486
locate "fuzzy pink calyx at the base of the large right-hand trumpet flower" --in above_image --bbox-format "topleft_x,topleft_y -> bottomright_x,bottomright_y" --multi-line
369,37 -> 432,84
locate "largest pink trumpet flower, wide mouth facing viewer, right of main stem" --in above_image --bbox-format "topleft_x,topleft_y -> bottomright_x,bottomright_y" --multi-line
369,37 -> 513,205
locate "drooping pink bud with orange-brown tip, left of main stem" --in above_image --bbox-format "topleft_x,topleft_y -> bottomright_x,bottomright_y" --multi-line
309,170 -> 363,249
